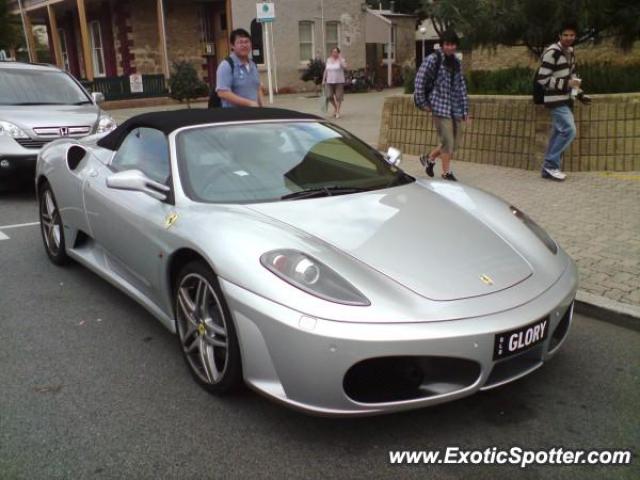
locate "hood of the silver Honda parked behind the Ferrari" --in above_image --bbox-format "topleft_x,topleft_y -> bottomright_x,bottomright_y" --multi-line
0,104 -> 100,130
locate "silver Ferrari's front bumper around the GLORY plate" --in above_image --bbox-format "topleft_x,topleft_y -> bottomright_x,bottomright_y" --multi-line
221,262 -> 577,416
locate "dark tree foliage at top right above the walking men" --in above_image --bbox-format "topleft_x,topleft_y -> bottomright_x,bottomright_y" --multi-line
422,0 -> 640,57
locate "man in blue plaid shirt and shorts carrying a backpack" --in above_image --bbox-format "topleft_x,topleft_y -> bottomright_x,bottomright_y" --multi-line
414,31 -> 469,182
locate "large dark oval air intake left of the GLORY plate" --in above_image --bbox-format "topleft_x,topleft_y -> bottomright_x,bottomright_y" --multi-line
343,356 -> 480,403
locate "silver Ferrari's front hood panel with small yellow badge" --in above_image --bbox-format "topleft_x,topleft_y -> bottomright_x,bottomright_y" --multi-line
248,183 -> 533,301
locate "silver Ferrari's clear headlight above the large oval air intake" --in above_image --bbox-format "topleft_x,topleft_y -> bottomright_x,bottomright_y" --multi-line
260,250 -> 371,306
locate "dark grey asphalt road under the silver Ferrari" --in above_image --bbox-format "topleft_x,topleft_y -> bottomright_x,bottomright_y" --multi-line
0,188 -> 640,480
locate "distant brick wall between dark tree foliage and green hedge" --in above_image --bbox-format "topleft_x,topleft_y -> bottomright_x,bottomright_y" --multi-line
465,40 -> 640,70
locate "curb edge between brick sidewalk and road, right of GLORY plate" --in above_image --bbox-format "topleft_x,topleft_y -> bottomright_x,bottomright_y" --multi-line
575,290 -> 640,332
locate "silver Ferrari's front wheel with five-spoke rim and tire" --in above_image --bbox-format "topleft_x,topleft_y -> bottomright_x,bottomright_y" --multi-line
175,261 -> 242,394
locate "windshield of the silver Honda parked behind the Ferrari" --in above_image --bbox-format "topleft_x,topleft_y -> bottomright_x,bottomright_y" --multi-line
0,68 -> 91,106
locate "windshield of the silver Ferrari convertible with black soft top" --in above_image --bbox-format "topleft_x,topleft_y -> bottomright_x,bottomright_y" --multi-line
176,122 -> 414,203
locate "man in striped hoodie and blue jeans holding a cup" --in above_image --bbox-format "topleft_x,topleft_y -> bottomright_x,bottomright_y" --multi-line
534,24 -> 591,182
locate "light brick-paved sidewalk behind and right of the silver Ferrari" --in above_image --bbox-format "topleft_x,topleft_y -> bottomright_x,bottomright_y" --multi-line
110,89 -> 640,318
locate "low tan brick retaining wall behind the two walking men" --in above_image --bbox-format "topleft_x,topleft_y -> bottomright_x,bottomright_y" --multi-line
379,94 -> 640,171
